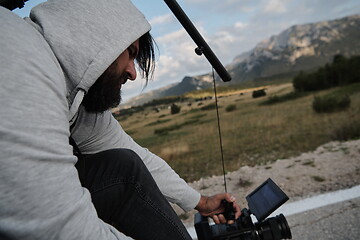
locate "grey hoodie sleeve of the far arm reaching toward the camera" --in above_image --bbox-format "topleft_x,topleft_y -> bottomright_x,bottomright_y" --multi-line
72,107 -> 200,211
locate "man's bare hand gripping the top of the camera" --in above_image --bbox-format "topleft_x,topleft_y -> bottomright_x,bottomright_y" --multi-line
195,193 -> 241,224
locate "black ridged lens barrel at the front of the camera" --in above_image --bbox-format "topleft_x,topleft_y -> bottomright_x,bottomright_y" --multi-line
255,214 -> 292,240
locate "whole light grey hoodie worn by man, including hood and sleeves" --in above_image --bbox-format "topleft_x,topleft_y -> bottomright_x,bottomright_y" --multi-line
0,0 -> 200,240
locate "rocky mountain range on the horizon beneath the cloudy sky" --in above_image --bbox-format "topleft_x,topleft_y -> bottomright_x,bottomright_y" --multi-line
123,15 -> 360,105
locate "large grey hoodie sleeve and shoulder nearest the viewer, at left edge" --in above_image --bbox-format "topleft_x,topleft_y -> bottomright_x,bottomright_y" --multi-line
0,7 -> 131,240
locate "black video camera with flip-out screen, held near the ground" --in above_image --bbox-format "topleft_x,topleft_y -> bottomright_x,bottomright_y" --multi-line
195,178 -> 292,240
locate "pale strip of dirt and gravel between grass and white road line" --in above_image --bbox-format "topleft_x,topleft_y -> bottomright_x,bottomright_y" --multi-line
175,140 -> 360,226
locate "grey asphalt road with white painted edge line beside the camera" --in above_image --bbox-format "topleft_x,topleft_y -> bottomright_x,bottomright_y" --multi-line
188,186 -> 360,240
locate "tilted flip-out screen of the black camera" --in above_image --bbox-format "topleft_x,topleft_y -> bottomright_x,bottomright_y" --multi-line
246,178 -> 289,221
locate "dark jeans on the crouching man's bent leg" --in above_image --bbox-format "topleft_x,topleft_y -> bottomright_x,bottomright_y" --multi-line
76,149 -> 191,240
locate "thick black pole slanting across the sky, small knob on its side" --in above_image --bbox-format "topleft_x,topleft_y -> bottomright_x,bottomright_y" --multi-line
164,0 -> 231,82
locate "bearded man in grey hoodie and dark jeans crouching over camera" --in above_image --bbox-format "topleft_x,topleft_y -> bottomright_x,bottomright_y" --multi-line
0,0 -> 240,240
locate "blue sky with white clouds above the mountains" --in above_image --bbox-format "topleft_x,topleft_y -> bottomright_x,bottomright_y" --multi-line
15,0 -> 360,102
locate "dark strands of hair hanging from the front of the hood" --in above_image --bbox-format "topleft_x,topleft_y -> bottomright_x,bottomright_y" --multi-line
136,32 -> 157,84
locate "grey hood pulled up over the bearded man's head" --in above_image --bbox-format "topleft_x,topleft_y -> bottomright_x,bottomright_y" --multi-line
27,0 -> 150,118
